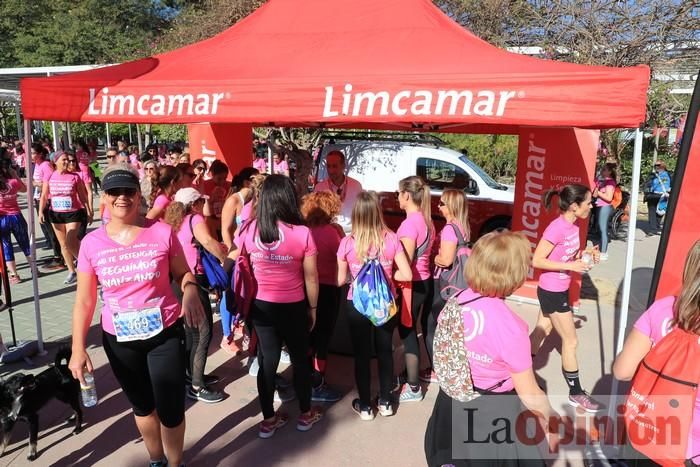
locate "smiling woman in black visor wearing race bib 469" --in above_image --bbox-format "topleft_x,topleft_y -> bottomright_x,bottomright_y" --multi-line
69,170 -> 204,466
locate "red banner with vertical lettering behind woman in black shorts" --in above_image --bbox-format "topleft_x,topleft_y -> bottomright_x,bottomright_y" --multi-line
512,128 -> 600,304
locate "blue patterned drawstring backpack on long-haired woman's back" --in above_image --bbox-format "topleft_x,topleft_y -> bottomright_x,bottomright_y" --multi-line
352,258 -> 397,326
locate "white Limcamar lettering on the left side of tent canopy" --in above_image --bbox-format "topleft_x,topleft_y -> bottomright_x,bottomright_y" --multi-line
88,88 -> 228,116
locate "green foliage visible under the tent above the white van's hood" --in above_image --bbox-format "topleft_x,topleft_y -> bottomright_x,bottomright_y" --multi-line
436,134 -> 518,181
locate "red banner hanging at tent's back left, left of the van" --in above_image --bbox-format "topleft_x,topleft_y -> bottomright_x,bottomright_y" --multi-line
187,123 -> 253,176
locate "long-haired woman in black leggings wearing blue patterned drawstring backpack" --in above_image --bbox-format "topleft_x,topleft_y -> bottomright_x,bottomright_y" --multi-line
338,191 -> 411,421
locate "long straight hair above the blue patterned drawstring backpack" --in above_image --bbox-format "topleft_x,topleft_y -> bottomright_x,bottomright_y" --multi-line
351,191 -> 389,261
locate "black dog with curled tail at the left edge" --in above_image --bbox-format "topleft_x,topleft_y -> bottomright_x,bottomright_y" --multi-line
0,347 -> 83,460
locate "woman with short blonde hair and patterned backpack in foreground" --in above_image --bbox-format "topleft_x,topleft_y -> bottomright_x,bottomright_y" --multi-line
424,232 -> 559,467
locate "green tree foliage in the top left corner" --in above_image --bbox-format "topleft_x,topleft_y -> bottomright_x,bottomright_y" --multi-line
0,0 -> 172,67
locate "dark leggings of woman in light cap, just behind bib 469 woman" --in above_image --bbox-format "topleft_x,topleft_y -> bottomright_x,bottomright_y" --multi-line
185,274 -> 214,388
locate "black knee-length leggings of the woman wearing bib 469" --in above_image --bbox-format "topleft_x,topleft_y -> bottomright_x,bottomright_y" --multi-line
102,321 -> 185,428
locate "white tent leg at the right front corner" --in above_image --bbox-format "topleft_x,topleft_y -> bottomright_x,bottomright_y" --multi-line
608,128 -> 644,444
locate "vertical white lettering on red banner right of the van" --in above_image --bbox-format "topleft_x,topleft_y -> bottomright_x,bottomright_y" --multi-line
521,133 -> 547,279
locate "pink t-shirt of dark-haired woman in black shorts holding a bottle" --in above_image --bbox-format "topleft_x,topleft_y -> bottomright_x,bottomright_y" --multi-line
539,215 -> 581,292
